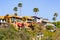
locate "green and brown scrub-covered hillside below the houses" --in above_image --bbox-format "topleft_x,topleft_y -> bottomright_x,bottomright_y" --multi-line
0,23 -> 60,40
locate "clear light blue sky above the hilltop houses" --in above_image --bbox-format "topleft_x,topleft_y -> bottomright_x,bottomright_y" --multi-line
0,0 -> 60,21
